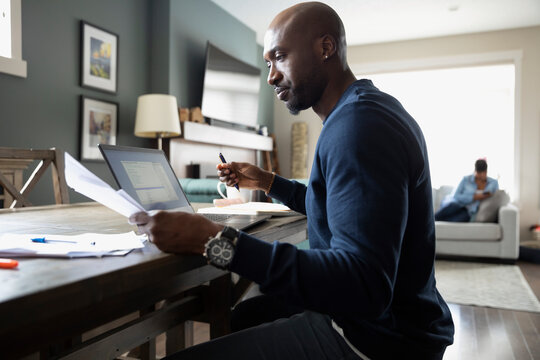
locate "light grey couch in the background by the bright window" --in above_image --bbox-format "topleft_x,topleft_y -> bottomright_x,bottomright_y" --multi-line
433,186 -> 519,261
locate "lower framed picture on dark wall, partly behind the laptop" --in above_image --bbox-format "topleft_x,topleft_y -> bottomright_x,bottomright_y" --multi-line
81,96 -> 118,160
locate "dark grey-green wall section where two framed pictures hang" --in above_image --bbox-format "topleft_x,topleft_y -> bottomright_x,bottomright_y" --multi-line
0,0 -> 151,204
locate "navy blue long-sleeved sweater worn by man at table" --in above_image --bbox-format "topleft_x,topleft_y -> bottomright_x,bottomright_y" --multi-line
231,80 -> 454,359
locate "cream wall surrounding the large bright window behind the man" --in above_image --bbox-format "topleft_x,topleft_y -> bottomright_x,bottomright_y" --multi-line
274,26 -> 540,240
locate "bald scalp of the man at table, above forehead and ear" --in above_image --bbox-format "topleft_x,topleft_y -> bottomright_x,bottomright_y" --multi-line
268,2 -> 347,66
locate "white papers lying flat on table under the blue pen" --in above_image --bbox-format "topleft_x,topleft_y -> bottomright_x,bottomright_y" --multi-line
0,231 -> 147,258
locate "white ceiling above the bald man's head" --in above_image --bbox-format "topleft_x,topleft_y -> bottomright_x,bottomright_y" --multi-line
212,0 -> 540,45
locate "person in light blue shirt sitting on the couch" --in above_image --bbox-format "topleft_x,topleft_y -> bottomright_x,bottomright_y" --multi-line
435,159 -> 499,222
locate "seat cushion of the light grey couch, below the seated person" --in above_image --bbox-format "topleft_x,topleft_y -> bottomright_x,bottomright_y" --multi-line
435,221 -> 502,241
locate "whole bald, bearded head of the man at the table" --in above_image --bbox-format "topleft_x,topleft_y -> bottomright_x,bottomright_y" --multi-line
264,2 -> 356,120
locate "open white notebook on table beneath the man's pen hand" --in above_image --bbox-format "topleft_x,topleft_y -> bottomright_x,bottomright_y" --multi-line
197,201 -> 302,216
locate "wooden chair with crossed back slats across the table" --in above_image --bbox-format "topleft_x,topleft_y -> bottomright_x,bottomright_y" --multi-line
0,147 -> 69,208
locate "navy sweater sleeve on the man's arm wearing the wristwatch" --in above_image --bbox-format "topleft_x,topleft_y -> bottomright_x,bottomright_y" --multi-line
231,105 -> 409,319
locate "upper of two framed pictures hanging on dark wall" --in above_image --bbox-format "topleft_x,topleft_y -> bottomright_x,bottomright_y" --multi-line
81,21 -> 118,93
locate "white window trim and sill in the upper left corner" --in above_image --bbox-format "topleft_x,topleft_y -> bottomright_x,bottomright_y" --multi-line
0,0 -> 26,78
